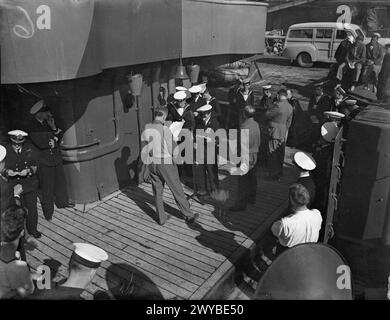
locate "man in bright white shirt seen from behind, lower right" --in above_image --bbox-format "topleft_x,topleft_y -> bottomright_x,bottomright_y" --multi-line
271,183 -> 322,254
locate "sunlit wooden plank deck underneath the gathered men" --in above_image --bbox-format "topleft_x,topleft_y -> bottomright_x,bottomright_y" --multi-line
27,155 -> 294,299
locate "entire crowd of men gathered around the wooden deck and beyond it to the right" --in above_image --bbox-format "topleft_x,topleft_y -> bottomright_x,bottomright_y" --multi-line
0,34 -> 390,299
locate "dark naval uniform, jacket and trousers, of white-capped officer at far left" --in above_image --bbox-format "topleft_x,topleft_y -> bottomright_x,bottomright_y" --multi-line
5,142 -> 38,234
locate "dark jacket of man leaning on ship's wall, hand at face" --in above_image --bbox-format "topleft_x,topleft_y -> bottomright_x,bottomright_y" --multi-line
29,119 -> 62,167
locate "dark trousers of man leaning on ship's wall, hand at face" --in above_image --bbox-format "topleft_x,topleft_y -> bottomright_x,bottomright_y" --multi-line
38,163 -> 69,220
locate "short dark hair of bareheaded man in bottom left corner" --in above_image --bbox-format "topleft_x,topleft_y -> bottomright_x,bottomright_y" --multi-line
1,205 -> 27,242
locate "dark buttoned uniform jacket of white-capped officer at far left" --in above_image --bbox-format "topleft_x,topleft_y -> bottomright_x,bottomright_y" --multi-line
5,142 -> 38,193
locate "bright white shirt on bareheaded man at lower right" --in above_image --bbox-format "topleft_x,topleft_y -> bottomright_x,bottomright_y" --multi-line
271,209 -> 322,248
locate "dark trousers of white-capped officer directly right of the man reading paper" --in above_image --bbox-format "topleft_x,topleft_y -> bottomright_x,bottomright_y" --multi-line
194,164 -> 219,193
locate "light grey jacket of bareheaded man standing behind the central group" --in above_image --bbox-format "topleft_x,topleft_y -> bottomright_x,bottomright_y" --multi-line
265,101 -> 293,140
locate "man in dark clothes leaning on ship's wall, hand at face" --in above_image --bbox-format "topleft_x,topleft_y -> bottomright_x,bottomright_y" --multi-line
29,100 -> 74,220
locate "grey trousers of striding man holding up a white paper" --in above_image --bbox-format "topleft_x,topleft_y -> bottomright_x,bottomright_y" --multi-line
149,163 -> 193,223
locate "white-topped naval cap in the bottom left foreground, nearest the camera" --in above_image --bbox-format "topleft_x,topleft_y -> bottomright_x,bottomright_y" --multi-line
71,243 -> 108,269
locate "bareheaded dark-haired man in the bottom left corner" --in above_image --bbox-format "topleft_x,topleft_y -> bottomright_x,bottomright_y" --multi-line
0,205 -> 34,299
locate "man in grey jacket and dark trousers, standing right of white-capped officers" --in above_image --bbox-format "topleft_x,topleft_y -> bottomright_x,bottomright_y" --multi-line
230,106 -> 261,211
